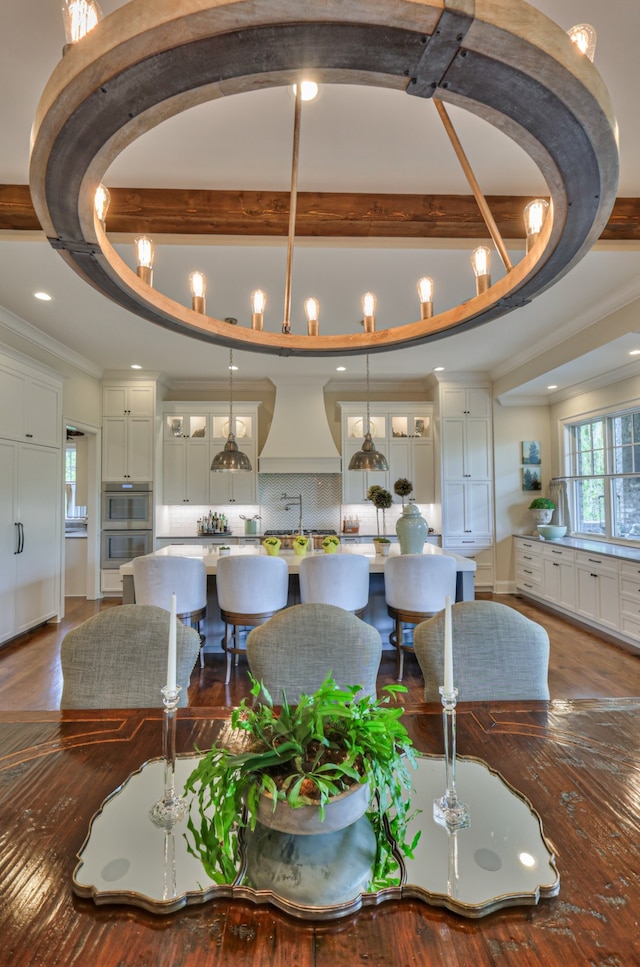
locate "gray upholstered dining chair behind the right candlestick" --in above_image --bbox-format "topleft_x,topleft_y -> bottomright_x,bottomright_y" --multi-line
413,601 -> 549,702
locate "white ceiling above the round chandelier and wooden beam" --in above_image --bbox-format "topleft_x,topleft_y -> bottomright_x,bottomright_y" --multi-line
0,0 -> 640,402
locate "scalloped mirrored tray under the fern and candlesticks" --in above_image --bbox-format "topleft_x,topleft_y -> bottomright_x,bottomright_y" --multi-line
73,755 -> 560,920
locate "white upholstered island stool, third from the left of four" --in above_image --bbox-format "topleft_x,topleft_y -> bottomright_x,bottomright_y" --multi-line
300,554 -> 369,617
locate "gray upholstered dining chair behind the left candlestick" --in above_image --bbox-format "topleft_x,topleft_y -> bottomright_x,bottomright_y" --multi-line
60,604 -> 200,708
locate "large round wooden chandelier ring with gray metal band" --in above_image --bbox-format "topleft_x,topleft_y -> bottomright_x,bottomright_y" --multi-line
30,0 -> 619,356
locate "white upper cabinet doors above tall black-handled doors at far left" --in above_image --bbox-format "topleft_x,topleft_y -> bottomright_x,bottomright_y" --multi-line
0,356 -> 62,448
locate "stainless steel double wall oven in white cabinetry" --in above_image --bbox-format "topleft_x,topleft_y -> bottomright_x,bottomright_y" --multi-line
100,481 -> 153,568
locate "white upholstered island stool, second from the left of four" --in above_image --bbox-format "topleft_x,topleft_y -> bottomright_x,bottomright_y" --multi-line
216,554 -> 289,685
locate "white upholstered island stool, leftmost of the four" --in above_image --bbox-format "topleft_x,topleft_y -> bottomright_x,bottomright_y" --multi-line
133,555 -> 207,668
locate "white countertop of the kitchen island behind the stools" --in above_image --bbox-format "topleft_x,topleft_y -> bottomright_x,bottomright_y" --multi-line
120,543 -> 476,575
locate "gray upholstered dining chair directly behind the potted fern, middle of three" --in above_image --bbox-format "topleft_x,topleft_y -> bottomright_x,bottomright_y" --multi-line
247,604 -> 382,705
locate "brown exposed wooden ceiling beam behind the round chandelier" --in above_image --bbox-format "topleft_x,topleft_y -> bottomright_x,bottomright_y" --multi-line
0,185 -> 640,241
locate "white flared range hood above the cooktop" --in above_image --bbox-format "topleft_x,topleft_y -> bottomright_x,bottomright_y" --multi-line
258,376 -> 341,473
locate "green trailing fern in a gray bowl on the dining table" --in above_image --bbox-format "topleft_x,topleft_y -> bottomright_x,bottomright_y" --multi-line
185,675 -> 419,889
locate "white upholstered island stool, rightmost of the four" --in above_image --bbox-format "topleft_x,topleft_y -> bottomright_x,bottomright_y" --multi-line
384,554 -> 456,682
